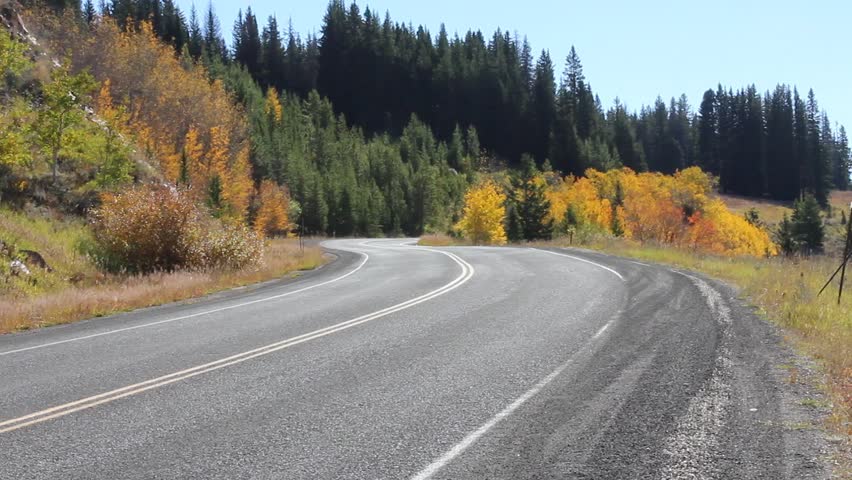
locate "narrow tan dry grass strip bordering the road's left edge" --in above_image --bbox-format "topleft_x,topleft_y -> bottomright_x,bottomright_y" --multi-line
0,239 -> 325,333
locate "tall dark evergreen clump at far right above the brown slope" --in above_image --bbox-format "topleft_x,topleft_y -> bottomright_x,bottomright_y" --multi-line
694,85 -> 850,206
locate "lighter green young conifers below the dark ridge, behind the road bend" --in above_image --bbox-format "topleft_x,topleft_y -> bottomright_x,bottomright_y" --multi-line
216,65 -> 472,236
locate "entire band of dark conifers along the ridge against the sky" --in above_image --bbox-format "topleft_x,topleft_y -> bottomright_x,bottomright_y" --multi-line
41,0 -> 850,205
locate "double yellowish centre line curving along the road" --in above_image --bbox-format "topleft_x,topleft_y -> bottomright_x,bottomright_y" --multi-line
0,250 -> 475,434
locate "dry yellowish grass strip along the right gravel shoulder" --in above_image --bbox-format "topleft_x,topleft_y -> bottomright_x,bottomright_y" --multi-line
544,234 -> 852,436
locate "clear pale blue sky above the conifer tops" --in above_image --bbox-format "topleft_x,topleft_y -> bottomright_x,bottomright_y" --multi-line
178,0 -> 852,129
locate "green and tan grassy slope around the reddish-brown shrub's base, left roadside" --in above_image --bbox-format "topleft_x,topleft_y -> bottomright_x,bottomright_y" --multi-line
0,209 -> 325,333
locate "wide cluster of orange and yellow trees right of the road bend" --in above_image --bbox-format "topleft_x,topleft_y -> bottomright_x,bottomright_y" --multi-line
548,167 -> 777,256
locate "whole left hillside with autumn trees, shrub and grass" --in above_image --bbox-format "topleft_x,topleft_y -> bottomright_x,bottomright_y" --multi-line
0,2 -> 324,333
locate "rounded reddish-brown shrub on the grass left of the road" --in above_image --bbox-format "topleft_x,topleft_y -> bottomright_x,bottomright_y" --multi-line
91,184 -> 263,273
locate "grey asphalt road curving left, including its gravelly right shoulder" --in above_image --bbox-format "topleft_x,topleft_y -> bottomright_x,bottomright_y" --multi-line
0,240 -> 828,479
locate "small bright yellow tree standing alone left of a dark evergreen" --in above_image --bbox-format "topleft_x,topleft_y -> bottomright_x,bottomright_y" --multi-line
456,181 -> 506,245
